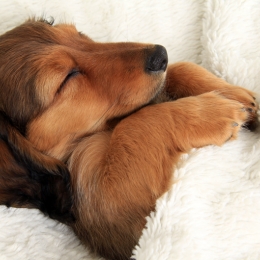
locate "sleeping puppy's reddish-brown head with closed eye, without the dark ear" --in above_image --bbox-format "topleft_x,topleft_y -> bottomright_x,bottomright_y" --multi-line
0,20 -> 167,159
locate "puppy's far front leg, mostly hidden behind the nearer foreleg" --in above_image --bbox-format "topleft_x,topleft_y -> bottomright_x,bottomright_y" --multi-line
165,62 -> 258,130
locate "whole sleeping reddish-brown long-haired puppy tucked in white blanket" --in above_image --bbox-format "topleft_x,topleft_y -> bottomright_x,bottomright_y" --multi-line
0,20 -> 258,260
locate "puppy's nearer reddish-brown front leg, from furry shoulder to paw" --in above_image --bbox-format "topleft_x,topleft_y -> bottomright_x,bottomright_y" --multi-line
69,92 -> 252,259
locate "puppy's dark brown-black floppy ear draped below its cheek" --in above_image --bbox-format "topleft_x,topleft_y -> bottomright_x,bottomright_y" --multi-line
0,111 -> 73,223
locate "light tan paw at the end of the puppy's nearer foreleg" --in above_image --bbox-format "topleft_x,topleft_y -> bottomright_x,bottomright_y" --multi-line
195,91 -> 252,147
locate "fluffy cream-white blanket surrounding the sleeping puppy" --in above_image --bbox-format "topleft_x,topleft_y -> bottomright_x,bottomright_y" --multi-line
0,0 -> 260,260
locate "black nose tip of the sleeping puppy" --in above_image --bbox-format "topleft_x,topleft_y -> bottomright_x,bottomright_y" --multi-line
145,45 -> 168,73
